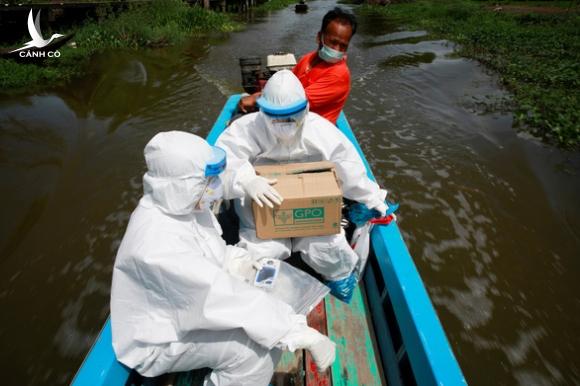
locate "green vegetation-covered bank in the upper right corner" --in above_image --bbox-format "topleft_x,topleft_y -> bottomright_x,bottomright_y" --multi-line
359,0 -> 580,149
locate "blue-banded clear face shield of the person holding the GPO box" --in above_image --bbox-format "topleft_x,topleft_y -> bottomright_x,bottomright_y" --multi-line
257,98 -> 308,141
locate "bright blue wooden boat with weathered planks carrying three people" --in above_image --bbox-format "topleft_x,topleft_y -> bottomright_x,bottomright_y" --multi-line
72,95 -> 466,386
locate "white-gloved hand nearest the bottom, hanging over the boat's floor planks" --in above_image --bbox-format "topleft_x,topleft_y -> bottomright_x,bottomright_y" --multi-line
280,315 -> 336,372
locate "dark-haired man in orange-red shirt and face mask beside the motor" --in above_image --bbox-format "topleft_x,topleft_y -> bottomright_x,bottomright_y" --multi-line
239,7 -> 357,124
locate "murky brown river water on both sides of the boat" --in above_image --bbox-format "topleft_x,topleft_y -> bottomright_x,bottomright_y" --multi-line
0,1 -> 580,385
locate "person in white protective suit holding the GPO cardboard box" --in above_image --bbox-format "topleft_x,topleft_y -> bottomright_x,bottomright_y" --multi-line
217,70 -> 387,294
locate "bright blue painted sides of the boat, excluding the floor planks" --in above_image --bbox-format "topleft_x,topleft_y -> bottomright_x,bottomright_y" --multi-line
72,95 -> 467,386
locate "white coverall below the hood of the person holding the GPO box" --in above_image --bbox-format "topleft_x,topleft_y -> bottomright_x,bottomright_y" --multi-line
216,101 -> 386,280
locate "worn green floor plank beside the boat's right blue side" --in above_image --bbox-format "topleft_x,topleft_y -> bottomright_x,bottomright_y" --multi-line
326,287 -> 384,386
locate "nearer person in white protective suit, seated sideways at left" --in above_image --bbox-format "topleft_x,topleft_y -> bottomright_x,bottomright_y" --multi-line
111,132 -> 335,386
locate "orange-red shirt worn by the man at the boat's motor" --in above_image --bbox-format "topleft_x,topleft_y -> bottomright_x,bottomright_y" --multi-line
292,51 -> 350,124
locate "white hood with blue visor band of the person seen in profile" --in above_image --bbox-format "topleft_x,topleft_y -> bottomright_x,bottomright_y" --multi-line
143,131 -> 225,215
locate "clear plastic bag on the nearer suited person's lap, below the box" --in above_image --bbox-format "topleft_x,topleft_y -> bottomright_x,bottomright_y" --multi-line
253,259 -> 330,315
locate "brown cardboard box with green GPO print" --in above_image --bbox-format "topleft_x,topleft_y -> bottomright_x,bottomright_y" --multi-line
252,161 -> 342,239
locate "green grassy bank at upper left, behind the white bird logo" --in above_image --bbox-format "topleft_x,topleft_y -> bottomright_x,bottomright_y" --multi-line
0,0 -> 241,92
